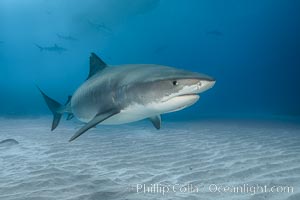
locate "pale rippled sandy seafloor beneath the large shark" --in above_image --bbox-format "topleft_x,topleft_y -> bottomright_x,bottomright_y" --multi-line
0,117 -> 300,200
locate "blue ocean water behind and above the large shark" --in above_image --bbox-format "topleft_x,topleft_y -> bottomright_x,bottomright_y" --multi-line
0,0 -> 300,119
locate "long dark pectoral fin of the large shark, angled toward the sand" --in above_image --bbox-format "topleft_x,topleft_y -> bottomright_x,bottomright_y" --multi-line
69,109 -> 120,142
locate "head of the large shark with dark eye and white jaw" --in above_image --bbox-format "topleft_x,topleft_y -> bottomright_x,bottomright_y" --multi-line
124,67 -> 216,114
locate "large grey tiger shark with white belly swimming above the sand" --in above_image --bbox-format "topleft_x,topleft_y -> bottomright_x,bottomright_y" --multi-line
38,53 -> 215,142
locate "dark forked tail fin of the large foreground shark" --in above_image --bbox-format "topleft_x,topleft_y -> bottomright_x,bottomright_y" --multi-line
37,86 -> 63,131
